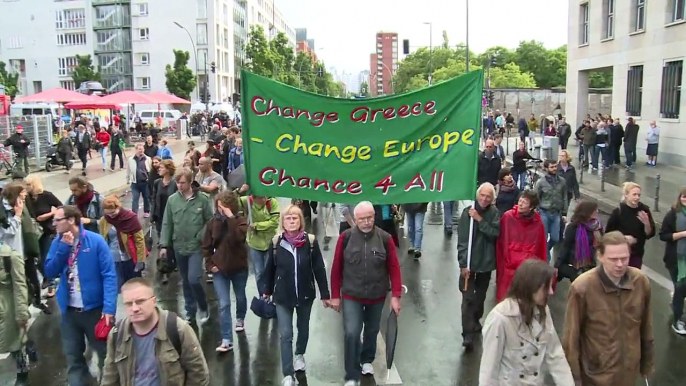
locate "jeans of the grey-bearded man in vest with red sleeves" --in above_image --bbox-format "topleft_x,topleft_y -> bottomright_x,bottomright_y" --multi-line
342,299 -> 384,381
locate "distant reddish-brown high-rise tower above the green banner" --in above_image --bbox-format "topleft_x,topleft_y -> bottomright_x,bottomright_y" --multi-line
369,32 -> 398,95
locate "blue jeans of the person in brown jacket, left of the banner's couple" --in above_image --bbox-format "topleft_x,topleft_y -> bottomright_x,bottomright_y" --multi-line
212,269 -> 248,343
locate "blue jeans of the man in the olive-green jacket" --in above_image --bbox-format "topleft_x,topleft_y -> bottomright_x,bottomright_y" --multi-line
174,250 -> 208,319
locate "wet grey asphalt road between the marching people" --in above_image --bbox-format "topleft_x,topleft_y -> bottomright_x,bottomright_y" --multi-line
0,198 -> 686,386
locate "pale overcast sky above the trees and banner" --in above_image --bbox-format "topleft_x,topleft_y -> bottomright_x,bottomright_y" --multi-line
274,0 -> 568,73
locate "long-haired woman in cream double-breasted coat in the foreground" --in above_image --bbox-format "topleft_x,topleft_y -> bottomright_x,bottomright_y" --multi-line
479,260 -> 574,386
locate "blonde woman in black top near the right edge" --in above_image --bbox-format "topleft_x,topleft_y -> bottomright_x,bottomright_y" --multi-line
605,182 -> 656,269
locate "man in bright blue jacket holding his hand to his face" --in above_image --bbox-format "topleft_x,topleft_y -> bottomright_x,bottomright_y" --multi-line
45,206 -> 117,386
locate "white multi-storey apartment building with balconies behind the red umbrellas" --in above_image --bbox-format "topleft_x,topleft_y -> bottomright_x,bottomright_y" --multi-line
0,0 -> 247,101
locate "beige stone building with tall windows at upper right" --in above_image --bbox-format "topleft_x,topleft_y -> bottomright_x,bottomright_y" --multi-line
566,0 -> 686,166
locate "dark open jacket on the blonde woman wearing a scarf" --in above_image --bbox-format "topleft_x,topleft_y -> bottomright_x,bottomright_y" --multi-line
261,234 -> 331,308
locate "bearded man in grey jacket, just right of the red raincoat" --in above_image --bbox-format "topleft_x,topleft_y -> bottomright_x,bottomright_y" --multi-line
534,160 -> 567,262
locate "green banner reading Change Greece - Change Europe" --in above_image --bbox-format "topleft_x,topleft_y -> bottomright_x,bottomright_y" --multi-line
241,71 -> 483,204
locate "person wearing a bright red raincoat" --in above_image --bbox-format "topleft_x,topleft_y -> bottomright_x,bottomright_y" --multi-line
496,190 -> 547,302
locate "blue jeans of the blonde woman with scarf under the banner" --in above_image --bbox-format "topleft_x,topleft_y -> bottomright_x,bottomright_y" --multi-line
276,300 -> 316,377
